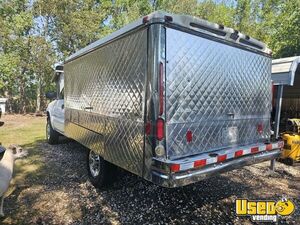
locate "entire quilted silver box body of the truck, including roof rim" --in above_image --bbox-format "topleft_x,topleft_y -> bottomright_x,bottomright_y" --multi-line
64,12 -> 271,186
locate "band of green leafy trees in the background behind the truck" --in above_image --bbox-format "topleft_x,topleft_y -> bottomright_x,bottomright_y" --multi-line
0,0 -> 300,113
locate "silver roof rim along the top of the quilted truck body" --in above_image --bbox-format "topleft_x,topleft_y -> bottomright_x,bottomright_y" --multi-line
66,11 -> 271,62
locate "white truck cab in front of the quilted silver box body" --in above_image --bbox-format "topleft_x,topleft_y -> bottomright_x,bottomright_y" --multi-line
46,65 -> 65,144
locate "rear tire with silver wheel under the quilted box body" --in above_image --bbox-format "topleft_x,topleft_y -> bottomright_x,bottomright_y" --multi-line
87,150 -> 114,189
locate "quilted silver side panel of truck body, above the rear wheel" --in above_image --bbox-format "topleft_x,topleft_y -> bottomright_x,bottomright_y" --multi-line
64,29 -> 147,175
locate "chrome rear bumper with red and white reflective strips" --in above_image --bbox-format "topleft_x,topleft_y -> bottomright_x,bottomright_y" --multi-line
152,142 -> 283,188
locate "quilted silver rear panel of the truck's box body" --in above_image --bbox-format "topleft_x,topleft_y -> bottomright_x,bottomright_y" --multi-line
166,28 -> 271,159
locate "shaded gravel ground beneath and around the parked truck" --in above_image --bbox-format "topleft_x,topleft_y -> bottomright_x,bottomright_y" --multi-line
0,140 -> 300,224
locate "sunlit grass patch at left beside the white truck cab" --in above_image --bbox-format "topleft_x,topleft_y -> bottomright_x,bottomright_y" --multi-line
0,115 -> 46,217
